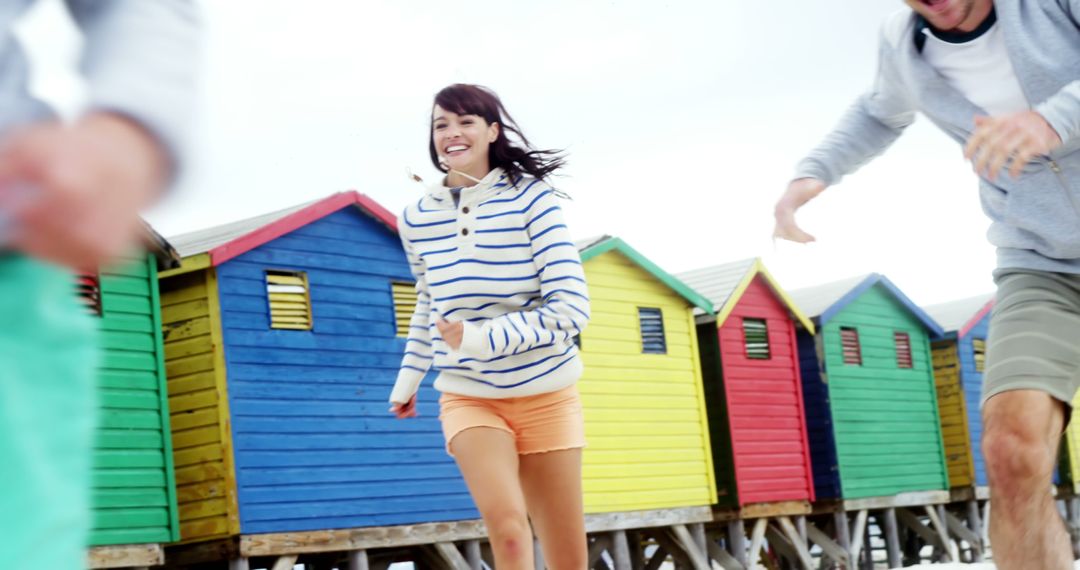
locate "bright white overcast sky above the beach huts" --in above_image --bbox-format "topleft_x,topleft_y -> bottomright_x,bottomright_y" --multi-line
16,0 -> 994,303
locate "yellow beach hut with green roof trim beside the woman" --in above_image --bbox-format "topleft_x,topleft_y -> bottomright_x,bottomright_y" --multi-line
578,235 -> 716,523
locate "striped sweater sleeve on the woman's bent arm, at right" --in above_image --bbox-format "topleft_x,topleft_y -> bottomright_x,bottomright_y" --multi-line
459,186 -> 590,359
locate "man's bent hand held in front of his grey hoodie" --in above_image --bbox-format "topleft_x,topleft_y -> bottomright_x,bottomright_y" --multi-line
963,111 -> 1062,181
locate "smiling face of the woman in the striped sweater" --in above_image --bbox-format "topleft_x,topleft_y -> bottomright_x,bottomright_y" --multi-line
431,105 -> 499,176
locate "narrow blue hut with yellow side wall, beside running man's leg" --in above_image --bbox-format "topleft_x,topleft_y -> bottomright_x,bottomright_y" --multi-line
926,294 -> 994,489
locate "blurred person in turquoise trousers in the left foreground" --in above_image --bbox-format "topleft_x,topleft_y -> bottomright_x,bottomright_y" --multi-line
0,0 -> 199,570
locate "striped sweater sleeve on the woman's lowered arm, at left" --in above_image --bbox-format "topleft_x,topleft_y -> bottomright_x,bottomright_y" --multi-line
390,220 -> 433,404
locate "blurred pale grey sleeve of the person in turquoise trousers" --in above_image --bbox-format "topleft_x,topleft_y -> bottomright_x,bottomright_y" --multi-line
65,0 -> 201,178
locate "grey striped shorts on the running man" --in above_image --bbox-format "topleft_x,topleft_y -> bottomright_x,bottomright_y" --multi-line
983,270 -> 1080,406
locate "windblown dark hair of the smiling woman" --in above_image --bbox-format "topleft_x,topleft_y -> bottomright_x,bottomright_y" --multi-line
428,83 -> 566,179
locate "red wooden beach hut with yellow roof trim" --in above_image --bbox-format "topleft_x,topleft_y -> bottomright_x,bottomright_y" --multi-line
678,258 -> 814,515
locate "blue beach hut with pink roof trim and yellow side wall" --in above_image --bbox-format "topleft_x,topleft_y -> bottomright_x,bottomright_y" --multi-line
161,191 -> 482,567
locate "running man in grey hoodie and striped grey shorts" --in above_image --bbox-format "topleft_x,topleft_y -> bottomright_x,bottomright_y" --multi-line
775,0 -> 1080,570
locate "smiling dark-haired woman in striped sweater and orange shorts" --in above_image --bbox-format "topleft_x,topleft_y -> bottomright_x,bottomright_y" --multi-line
390,84 -> 590,570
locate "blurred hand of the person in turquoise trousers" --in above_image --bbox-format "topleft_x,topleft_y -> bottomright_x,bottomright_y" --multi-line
0,112 -> 168,270
